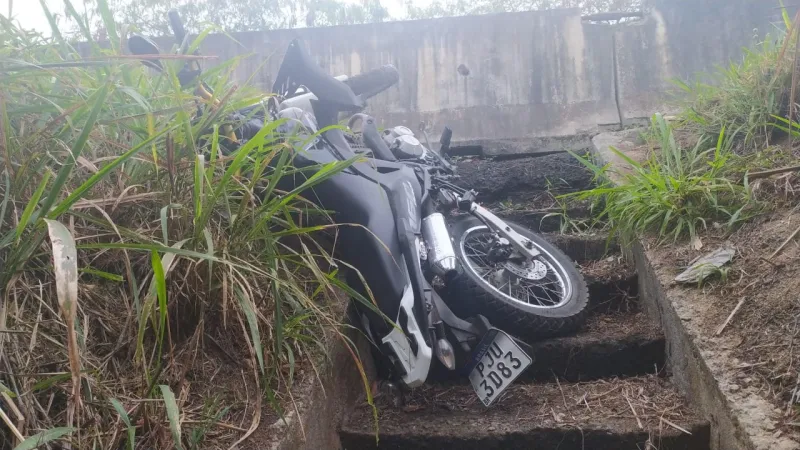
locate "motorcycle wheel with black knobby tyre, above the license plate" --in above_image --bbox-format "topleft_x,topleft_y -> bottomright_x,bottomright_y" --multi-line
447,216 -> 589,337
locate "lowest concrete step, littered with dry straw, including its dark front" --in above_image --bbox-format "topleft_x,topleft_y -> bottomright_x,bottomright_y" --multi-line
339,375 -> 710,450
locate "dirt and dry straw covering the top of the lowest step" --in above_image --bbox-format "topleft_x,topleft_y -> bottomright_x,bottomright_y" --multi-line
350,375 -> 698,440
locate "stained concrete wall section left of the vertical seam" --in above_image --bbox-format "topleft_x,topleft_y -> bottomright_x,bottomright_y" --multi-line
195,9 -> 617,146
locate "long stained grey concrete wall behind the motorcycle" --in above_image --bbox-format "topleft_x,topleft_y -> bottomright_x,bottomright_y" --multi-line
191,0 -> 792,147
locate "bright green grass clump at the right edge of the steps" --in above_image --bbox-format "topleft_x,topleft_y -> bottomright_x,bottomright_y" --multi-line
564,115 -> 759,244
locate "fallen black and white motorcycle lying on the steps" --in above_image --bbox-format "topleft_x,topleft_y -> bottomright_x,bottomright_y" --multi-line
128,11 -> 588,406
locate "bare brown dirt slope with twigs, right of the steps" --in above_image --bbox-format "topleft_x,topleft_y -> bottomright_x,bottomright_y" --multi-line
648,201 -> 800,438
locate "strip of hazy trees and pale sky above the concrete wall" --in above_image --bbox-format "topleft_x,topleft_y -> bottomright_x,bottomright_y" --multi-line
4,0 -> 642,38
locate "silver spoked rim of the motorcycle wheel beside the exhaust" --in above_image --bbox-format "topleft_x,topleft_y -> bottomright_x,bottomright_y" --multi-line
459,225 -> 572,312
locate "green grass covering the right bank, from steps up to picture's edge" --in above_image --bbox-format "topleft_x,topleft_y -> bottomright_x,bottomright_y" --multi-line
564,3 -> 800,248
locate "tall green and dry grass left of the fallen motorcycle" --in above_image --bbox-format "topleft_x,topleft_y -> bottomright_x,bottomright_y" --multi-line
0,2 -> 366,449
